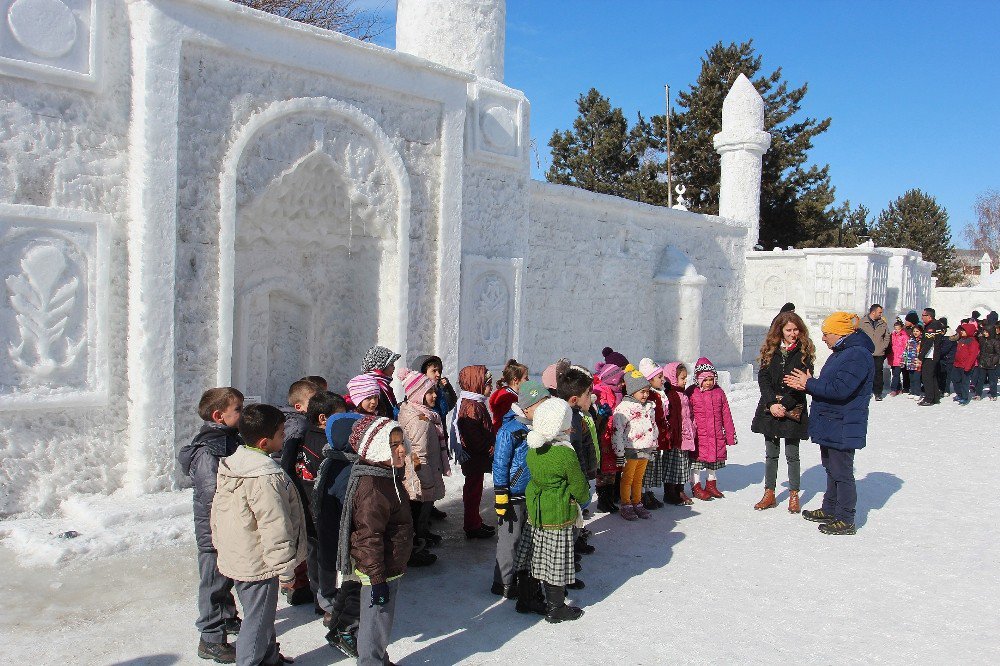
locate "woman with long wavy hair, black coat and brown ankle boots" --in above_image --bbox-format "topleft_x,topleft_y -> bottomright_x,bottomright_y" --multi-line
750,312 -> 816,513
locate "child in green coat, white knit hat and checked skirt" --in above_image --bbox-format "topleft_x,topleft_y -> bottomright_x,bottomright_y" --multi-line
515,398 -> 590,622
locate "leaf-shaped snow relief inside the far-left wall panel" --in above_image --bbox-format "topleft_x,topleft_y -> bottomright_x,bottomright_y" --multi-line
6,245 -> 86,377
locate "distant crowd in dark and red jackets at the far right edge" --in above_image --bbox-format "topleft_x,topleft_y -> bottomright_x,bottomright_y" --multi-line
888,311 -> 1000,405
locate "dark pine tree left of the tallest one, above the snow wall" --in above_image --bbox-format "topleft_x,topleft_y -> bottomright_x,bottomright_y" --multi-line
545,88 -> 665,202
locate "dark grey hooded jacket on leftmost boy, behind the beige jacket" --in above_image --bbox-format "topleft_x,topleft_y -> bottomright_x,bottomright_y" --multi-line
177,421 -> 242,553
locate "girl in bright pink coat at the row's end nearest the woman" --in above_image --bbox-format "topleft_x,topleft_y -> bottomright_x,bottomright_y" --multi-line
687,357 -> 736,500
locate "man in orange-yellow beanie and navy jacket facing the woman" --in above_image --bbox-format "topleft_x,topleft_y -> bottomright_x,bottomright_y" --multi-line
785,312 -> 875,534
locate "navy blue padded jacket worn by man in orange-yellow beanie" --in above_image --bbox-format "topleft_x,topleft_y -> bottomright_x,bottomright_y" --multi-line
806,331 -> 875,450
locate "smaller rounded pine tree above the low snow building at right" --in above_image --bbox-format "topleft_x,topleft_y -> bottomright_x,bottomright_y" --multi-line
872,189 -> 962,287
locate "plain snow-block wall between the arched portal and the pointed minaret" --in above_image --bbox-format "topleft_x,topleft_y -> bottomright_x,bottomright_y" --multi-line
521,182 -> 749,381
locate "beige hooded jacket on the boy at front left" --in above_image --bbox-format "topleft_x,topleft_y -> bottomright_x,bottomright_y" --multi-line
212,446 -> 307,582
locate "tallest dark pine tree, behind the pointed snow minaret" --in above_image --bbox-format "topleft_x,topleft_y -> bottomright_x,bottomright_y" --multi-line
664,40 -> 839,247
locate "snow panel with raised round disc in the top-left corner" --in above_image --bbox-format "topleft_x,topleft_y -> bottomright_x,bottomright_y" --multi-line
0,0 -> 100,89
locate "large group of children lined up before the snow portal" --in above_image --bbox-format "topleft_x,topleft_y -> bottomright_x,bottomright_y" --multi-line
178,346 -> 736,666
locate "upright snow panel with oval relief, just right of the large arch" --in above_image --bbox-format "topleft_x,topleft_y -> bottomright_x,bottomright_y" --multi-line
459,255 -> 523,368
